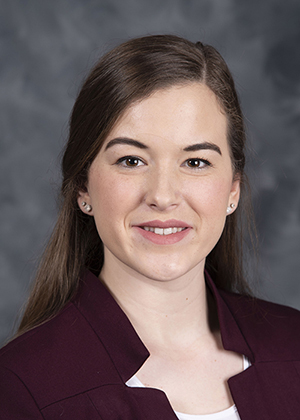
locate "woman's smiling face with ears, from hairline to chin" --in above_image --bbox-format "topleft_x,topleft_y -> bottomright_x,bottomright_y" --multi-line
78,83 -> 239,281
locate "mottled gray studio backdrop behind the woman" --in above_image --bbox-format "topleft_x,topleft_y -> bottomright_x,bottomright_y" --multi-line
0,0 -> 300,342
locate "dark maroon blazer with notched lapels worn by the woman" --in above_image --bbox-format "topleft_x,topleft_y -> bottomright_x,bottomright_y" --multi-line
0,272 -> 300,420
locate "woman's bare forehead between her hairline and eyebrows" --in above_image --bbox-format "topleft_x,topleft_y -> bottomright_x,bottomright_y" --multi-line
104,83 -> 227,146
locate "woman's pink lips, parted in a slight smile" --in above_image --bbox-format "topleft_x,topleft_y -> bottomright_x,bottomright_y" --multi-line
133,219 -> 192,245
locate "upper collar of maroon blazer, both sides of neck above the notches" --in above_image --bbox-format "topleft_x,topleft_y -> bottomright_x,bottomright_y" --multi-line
73,271 -> 253,382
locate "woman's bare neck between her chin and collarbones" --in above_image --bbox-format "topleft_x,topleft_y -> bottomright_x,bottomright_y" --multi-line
100,253 -> 215,350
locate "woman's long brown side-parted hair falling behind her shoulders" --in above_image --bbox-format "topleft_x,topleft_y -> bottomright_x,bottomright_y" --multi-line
18,35 -> 255,334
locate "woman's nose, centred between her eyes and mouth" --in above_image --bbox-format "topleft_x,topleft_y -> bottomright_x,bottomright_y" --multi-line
145,168 -> 180,211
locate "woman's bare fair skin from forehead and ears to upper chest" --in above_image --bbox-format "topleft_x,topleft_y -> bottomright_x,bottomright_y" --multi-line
78,83 -> 242,414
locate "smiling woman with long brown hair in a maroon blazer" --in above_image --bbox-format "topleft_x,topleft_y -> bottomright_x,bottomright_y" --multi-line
0,36 -> 300,420
